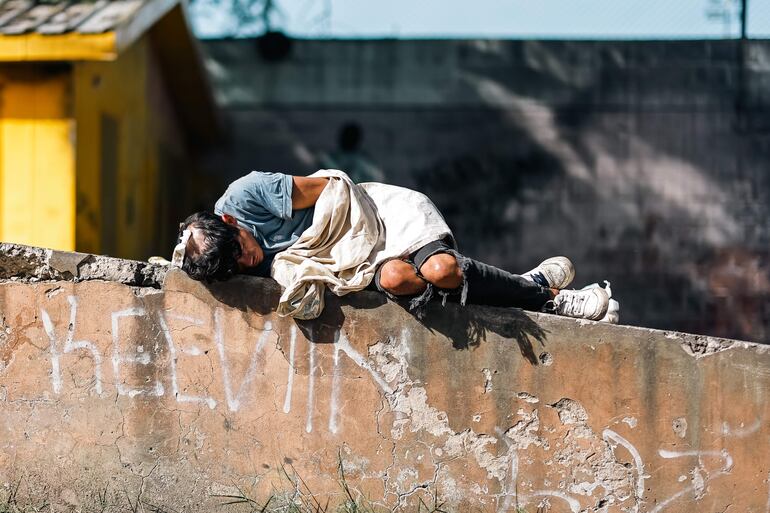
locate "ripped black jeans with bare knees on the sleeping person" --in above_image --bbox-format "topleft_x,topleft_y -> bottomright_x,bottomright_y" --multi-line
374,239 -> 553,317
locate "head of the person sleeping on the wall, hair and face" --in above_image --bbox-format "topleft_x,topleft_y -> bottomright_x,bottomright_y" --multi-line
179,212 -> 264,281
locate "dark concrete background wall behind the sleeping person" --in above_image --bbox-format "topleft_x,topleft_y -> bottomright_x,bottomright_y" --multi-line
200,40 -> 770,342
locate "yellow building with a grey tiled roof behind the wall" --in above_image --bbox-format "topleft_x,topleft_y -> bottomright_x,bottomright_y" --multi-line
0,0 -> 220,259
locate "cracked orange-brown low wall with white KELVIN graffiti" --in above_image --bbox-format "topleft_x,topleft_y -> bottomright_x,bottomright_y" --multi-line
0,245 -> 770,513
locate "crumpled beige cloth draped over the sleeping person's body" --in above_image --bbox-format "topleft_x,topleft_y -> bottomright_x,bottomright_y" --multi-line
271,169 -> 452,319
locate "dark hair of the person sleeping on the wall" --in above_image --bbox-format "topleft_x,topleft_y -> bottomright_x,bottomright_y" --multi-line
179,212 -> 241,282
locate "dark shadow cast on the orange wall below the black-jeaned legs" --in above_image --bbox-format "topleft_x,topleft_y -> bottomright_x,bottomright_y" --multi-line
399,301 -> 548,365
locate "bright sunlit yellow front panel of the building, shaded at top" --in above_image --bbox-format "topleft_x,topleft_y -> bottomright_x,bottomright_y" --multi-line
0,67 -> 75,250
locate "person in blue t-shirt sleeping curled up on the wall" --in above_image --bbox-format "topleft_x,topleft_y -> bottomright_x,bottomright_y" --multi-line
174,170 -> 609,320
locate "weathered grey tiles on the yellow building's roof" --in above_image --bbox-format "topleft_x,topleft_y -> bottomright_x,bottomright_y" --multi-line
0,0 -> 148,36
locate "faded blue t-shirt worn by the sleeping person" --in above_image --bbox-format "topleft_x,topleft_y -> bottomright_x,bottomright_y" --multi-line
214,171 -> 313,275
